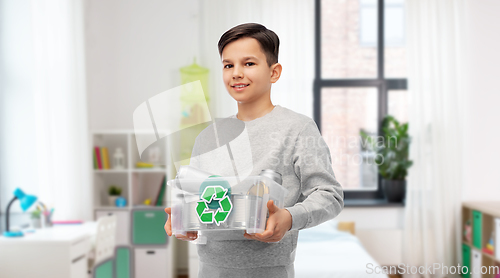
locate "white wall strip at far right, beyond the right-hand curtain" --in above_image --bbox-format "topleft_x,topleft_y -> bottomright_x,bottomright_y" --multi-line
457,0 -> 500,201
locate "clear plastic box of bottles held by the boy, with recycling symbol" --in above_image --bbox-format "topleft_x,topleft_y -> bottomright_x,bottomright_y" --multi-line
168,176 -> 288,238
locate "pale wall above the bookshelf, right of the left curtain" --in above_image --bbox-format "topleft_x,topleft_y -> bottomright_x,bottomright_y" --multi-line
86,0 -> 199,129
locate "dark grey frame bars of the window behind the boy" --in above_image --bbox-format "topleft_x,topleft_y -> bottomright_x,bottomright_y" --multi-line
313,0 -> 408,201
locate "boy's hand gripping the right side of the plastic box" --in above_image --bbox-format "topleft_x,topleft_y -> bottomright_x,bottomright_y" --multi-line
244,200 -> 292,242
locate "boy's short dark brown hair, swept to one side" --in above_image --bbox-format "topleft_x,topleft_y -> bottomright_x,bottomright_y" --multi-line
218,23 -> 280,66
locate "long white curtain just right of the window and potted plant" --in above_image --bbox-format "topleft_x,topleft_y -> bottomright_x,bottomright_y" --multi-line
403,0 -> 465,277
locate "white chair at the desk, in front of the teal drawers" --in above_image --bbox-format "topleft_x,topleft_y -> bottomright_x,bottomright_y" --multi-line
90,215 -> 116,278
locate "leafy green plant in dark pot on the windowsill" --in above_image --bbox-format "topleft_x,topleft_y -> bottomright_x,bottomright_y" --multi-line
360,115 -> 413,202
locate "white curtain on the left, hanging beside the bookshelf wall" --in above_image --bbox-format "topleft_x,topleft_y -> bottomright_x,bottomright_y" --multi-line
32,0 -> 92,222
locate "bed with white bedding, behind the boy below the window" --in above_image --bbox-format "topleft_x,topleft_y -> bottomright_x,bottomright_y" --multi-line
295,220 -> 387,278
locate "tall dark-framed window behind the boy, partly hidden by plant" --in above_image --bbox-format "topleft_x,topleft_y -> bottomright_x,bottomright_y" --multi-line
314,0 -> 408,199
